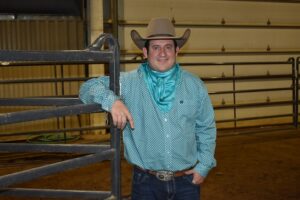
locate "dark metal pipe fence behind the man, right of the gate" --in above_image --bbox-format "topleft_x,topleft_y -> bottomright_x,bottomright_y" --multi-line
121,58 -> 298,128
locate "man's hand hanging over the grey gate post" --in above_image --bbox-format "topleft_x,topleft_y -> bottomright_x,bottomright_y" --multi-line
111,100 -> 134,129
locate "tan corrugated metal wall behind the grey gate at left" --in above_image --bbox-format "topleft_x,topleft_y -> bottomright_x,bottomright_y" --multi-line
0,18 -> 84,138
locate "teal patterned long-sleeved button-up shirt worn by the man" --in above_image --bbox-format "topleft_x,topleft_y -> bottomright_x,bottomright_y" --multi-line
79,66 -> 216,176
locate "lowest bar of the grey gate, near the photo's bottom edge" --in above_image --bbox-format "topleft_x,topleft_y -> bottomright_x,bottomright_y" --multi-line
0,188 -> 111,200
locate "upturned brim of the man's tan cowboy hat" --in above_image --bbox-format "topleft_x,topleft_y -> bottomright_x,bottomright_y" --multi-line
130,29 -> 191,49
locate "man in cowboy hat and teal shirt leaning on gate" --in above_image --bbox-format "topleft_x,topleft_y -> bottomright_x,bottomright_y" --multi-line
80,18 -> 216,200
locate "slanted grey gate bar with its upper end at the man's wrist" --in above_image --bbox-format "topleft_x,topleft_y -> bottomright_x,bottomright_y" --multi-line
0,104 -> 104,125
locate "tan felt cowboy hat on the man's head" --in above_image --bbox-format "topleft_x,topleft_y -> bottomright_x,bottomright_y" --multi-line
131,18 -> 191,49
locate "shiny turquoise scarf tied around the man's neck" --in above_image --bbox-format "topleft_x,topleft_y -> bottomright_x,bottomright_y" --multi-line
142,62 -> 180,112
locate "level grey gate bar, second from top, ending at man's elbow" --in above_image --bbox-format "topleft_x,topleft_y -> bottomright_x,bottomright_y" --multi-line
0,97 -> 82,106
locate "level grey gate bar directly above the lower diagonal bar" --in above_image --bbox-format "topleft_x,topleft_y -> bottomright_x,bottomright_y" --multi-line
0,143 -> 110,154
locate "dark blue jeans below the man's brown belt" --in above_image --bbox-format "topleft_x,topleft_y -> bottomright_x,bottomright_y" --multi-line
131,168 -> 200,200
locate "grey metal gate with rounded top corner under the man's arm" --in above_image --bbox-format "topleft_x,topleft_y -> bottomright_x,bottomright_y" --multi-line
0,34 -> 121,200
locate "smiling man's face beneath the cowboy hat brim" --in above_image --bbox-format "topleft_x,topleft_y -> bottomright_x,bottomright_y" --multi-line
143,40 -> 179,72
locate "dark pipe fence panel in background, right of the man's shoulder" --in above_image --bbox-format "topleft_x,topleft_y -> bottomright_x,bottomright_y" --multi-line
121,57 -> 300,130
